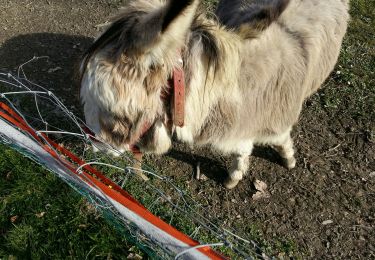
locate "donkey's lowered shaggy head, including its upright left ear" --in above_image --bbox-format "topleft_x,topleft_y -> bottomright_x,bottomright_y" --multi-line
81,0 -> 199,153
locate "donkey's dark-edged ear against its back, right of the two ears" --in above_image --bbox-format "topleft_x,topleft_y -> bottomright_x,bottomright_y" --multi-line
217,0 -> 290,38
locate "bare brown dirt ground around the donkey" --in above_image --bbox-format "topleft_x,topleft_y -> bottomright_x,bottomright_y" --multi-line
0,0 -> 375,259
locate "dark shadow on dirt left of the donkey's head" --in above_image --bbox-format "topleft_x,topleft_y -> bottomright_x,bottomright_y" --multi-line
0,33 -> 92,112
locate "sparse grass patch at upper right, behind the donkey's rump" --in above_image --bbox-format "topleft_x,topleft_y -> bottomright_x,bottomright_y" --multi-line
319,0 -> 375,126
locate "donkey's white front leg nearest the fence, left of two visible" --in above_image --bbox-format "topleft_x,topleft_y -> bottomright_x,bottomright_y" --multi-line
224,146 -> 253,189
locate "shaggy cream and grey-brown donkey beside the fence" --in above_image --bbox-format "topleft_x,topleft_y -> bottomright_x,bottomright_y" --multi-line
80,0 -> 349,188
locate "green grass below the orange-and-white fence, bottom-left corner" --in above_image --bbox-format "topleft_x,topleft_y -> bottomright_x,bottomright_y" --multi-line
0,145 -> 139,259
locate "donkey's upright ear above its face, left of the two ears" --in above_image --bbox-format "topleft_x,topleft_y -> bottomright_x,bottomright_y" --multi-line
121,0 -> 199,57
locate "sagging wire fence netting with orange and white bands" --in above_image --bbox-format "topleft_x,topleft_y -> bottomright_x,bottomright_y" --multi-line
0,57 -> 267,259
